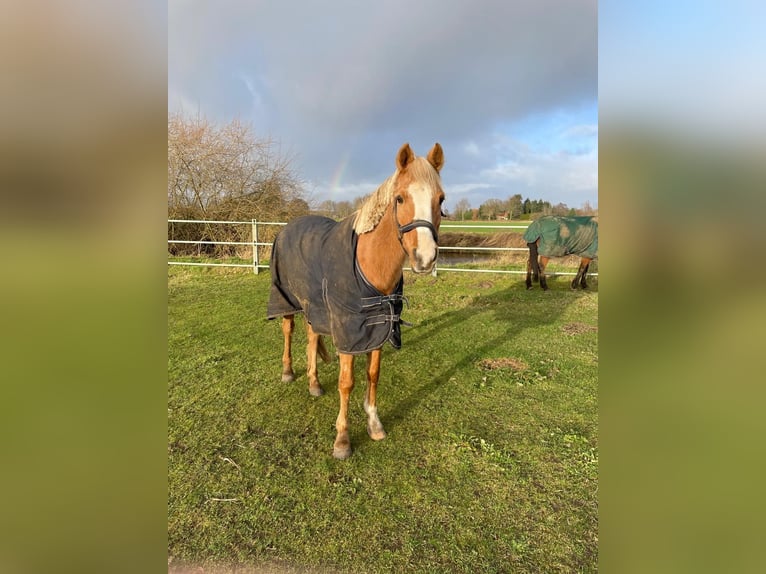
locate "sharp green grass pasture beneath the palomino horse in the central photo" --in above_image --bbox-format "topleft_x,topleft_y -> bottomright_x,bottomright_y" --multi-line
168,267 -> 598,573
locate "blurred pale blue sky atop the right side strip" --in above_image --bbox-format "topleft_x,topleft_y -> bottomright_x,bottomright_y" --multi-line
598,0 -> 766,145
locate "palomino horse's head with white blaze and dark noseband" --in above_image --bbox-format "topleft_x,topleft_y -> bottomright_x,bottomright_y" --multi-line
392,143 -> 444,273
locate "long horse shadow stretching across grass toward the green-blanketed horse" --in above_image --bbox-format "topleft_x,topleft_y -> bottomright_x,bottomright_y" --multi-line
385,280 -> 598,429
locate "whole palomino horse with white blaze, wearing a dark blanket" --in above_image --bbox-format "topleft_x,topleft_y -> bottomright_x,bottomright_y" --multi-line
267,143 -> 444,460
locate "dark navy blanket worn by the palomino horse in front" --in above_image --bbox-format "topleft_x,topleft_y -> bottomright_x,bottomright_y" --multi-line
266,215 -> 405,354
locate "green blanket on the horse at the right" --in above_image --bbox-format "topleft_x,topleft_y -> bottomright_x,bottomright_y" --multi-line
524,215 -> 598,259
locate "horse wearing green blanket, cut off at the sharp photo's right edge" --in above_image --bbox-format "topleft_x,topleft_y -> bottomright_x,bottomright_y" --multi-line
524,215 -> 598,291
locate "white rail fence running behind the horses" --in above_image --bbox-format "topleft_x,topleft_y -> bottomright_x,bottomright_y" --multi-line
168,219 -> 598,277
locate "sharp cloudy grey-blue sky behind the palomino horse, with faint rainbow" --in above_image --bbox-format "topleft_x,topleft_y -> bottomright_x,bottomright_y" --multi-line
168,0 -> 599,210
